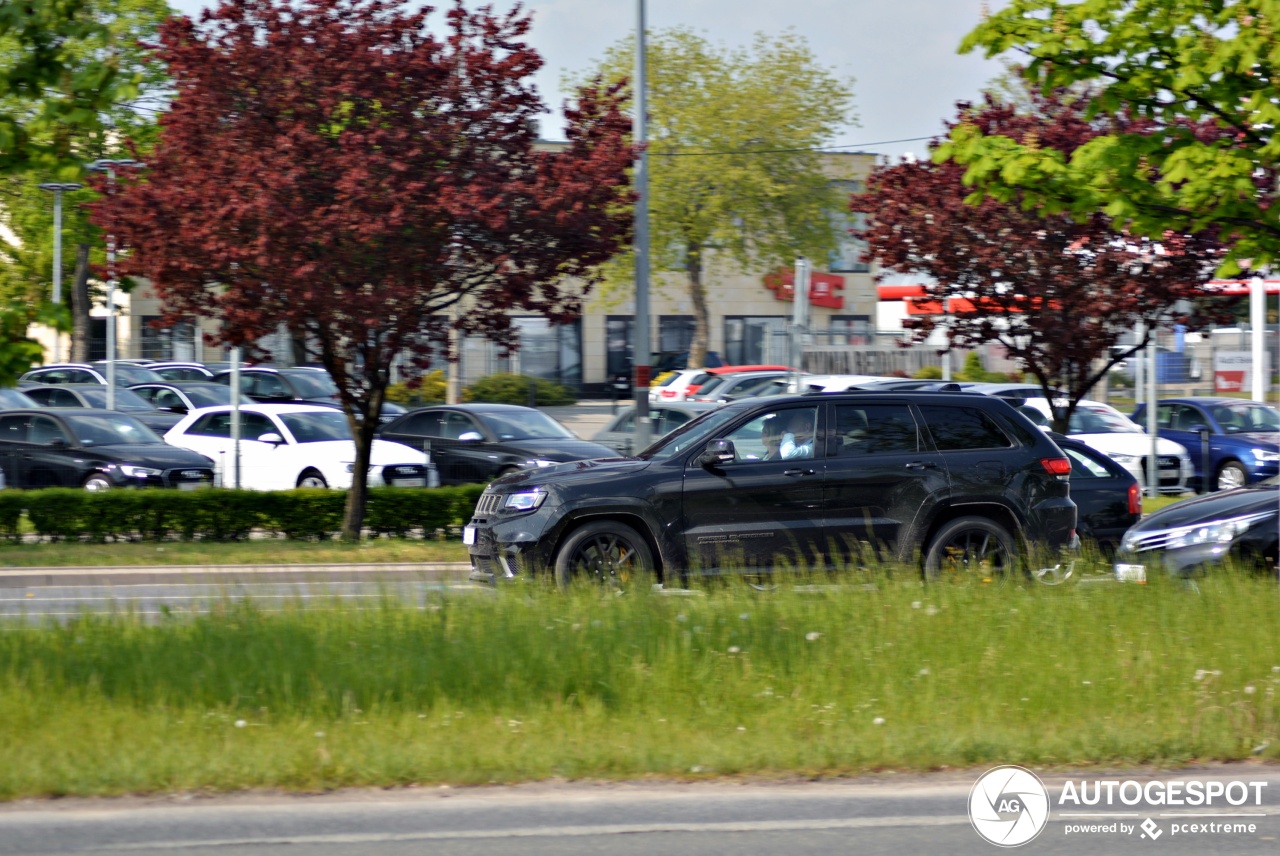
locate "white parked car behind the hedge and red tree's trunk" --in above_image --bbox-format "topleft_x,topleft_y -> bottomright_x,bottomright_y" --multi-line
164,404 -> 426,490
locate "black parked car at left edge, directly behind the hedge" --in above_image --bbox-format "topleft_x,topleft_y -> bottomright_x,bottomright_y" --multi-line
0,408 -> 214,490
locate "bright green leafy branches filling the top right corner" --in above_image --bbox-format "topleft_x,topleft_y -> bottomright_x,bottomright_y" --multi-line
937,0 -> 1280,275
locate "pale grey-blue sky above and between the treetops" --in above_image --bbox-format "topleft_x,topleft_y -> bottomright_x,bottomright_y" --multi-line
169,0 -> 1005,156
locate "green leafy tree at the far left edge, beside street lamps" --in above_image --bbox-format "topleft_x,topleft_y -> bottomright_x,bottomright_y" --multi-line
0,0 -> 173,371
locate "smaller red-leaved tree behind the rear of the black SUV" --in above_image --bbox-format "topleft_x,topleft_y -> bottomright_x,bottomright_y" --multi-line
851,93 -> 1228,430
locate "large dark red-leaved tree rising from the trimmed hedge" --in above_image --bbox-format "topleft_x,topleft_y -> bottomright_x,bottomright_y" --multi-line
95,0 -> 635,537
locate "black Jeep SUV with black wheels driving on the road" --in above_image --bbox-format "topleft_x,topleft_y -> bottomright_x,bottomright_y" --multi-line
463,393 -> 1076,585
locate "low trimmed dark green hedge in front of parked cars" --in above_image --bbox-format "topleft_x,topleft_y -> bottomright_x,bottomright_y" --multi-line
0,485 -> 484,541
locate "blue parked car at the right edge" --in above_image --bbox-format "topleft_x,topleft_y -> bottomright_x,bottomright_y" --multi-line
1133,398 -> 1280,490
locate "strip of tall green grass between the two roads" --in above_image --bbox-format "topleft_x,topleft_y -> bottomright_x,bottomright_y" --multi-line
0,573 -> 1280,798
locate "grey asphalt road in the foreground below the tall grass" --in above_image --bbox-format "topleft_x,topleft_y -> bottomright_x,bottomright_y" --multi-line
0,768 -> 1280,856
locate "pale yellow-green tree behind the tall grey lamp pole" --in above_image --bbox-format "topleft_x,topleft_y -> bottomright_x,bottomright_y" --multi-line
581,28 -> 854,366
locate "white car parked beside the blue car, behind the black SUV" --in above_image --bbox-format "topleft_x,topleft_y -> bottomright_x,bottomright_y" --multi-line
1023,398 -> 1196,494
